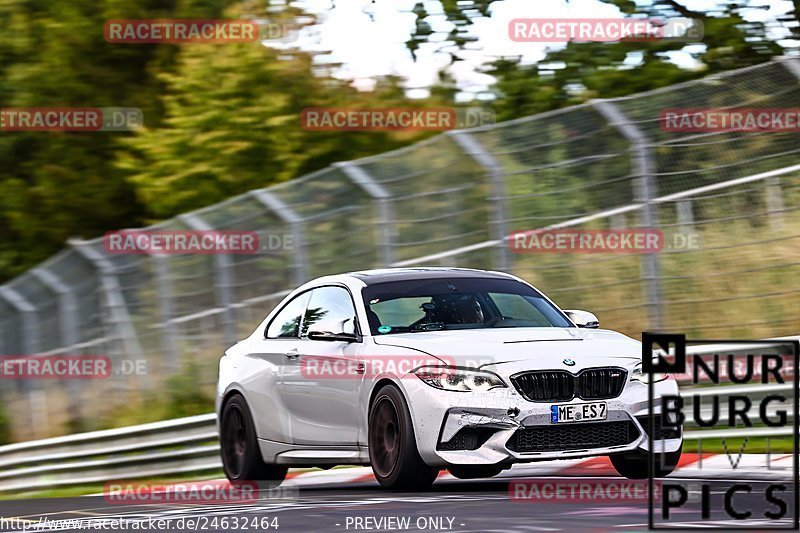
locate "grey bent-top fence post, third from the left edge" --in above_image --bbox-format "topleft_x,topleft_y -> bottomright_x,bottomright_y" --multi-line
68,239 -> 143,359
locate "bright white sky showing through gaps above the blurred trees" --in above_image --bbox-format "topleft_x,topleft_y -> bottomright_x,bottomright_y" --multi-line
270,0 -> 792,100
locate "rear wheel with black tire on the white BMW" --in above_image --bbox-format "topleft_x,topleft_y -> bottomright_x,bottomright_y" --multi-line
219,394 -> 289,488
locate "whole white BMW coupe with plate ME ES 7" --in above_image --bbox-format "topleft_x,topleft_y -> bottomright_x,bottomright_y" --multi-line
217,268 -> 682,489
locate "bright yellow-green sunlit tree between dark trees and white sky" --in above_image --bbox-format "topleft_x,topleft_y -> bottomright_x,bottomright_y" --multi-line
119,35 -> 418,219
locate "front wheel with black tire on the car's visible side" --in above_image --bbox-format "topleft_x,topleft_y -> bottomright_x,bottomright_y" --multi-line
367,385 -> 439,490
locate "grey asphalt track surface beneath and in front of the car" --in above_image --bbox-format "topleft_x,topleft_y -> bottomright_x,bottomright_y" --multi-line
0,477 -> 794,532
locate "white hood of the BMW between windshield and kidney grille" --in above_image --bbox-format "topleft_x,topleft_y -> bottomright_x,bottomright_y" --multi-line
374,328 -> 642,374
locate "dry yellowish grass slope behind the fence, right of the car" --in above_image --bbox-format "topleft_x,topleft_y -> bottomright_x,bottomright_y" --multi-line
513,210 -> 800,339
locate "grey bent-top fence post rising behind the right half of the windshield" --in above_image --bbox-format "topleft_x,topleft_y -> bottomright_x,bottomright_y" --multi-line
447,130 -> 511,271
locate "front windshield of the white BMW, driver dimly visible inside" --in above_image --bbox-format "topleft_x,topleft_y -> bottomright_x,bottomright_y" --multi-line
362,278 -> 574,335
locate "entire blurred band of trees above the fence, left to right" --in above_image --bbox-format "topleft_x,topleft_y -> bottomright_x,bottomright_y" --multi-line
0,0 -> 800,281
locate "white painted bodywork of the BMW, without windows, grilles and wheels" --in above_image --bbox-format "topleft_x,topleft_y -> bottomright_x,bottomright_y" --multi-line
217,269 -> 681,467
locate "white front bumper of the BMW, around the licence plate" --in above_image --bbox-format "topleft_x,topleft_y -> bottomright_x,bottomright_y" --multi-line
402,378 -> 682,467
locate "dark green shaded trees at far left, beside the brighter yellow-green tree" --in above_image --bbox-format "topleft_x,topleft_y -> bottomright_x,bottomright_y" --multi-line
0,0 -> 231,279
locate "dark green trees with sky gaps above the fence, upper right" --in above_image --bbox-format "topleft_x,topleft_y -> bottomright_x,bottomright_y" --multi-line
487,0 -> 783,120
